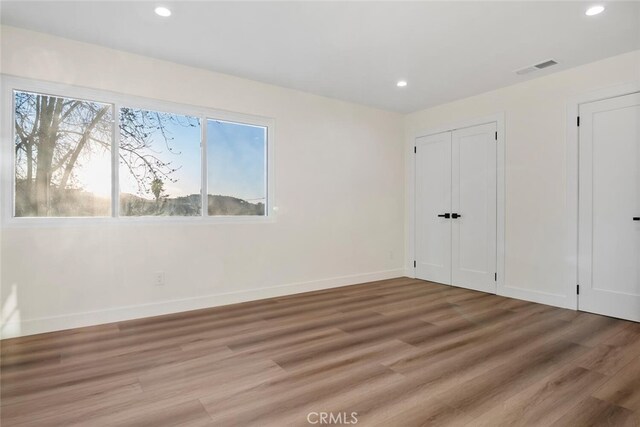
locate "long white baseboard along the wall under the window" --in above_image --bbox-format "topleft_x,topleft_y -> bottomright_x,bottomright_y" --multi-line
0,268 -> 404,339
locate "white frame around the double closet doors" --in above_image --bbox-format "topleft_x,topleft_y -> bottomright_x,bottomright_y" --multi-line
405,112 -> 506,295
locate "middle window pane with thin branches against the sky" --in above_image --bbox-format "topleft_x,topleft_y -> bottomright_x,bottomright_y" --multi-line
120,108 -> 202,216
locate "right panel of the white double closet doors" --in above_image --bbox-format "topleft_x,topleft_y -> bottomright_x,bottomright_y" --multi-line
451,123 -> 496,293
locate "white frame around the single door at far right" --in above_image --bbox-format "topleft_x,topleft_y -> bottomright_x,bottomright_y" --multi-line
566,82 -> 640,310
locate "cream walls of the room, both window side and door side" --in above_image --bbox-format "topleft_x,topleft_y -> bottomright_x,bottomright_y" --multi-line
0,27 -> 640,337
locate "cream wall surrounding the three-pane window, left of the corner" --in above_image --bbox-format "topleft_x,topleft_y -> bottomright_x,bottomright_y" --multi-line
1,27 -> 404,337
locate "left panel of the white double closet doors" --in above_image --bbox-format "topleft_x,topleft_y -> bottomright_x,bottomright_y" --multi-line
415,132 -> 451,284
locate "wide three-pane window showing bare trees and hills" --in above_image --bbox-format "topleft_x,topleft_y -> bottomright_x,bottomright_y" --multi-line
3,77 -> 272,220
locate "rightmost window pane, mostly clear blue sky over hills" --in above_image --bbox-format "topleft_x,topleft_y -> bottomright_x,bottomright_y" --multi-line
207,120 -> 267,215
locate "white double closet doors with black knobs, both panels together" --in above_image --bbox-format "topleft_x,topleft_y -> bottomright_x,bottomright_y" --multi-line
415,122 -> 497,293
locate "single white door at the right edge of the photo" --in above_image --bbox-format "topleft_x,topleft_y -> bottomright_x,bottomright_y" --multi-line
578,94 -> 640,321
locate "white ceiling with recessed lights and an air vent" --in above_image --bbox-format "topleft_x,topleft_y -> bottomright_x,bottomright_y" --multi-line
0,0 -> 640,112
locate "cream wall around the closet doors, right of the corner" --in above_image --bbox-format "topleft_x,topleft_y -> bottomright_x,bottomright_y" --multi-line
405,51 -> 640,307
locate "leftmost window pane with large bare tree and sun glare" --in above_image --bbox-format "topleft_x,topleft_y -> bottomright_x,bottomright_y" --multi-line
14,91 -> 113,217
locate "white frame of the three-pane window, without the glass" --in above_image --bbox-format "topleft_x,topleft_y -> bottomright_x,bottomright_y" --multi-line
0,74 -> 277,227
